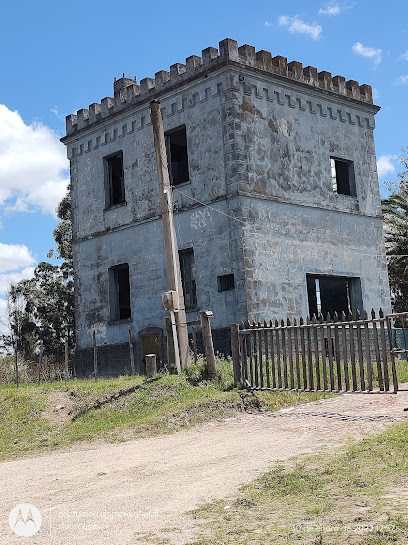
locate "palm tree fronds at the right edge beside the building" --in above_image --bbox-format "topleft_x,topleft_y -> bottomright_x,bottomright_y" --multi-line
382,148 -> 408,312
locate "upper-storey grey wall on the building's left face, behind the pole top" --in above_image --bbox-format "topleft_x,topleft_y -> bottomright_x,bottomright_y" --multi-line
68,77 -> 225,239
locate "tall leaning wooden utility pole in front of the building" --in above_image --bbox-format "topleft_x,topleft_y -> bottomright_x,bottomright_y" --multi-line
150,100 -> 190,369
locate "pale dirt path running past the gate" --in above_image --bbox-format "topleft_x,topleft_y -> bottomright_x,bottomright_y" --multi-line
0,391 -> 408,545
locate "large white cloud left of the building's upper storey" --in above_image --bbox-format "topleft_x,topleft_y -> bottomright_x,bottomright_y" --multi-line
0,104 -> 68,214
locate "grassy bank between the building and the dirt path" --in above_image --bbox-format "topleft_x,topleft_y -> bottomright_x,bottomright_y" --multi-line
0,361 -> 329,459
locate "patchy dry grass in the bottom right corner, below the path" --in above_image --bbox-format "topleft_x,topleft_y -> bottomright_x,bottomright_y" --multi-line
193,423 -> 408,545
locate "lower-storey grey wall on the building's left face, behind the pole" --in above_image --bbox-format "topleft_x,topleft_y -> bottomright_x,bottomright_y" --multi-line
75,201 -> 246,349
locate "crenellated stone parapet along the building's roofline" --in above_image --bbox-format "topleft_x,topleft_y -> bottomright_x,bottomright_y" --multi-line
66,38 -> 373,136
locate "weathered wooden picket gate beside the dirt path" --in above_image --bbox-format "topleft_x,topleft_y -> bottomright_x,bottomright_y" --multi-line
231,309 -> 400,393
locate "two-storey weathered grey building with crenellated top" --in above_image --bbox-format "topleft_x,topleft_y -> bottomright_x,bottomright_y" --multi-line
62,39 -> 390,374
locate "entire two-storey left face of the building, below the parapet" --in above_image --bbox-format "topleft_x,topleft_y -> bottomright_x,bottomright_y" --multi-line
69,69 -> 246,356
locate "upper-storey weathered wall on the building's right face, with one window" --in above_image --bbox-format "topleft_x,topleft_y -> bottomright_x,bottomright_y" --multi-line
231,72 -> 381,216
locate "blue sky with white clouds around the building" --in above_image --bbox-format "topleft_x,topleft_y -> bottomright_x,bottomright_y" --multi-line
0,0 -> 408,324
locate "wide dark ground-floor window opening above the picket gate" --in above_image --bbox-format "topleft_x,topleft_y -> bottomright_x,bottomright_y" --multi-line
306,274 -> 362,317
